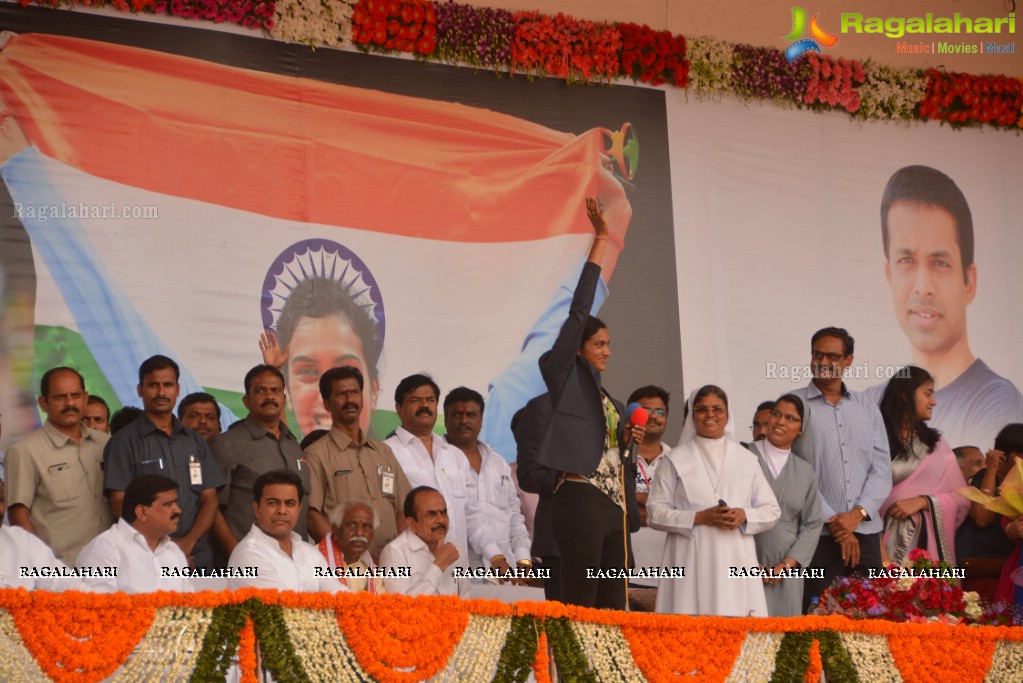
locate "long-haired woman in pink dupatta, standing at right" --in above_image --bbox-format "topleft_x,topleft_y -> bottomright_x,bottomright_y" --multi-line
881,365 -> 970,565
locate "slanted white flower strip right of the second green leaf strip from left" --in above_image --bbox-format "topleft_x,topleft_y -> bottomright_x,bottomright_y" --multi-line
283,607 -> 373,683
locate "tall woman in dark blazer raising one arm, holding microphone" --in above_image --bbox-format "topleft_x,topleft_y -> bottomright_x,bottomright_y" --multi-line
537,198 -> 642,609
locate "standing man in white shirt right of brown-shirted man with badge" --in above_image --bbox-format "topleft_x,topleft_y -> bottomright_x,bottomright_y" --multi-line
384,374 -> 510,573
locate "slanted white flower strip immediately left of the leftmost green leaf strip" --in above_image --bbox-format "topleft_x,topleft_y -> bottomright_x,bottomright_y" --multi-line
110,607 -> 213,683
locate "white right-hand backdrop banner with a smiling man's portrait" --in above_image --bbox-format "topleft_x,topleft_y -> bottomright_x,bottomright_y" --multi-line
668,92 -> 1023,449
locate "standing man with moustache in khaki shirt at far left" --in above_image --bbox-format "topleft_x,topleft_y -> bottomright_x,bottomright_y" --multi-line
6,367 -> 113,565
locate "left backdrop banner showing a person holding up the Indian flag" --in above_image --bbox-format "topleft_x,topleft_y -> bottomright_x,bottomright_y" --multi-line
0,6 -> 681,458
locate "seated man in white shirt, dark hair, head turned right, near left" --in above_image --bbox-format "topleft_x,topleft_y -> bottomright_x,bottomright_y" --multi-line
75,474 -> 192,593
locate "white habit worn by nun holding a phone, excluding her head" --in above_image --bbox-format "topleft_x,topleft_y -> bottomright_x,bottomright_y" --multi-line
647,437 -> 782,617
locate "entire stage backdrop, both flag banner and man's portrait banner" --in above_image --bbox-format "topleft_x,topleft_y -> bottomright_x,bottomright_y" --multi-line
0,5 -> 1023,458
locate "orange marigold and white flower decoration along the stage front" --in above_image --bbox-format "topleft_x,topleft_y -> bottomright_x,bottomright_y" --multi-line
0,589 -> 1023,683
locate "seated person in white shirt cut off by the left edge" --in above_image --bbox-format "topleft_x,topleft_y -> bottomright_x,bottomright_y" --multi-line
0,480 -> 85,591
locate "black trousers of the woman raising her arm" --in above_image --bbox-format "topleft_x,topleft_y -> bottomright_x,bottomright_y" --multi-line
551,481 -> 632,609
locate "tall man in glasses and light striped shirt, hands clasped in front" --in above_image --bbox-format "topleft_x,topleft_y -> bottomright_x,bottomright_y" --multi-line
793,327 -> 892,612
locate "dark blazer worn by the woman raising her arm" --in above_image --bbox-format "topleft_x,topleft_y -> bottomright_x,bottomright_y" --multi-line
536,262 -> 639,531
